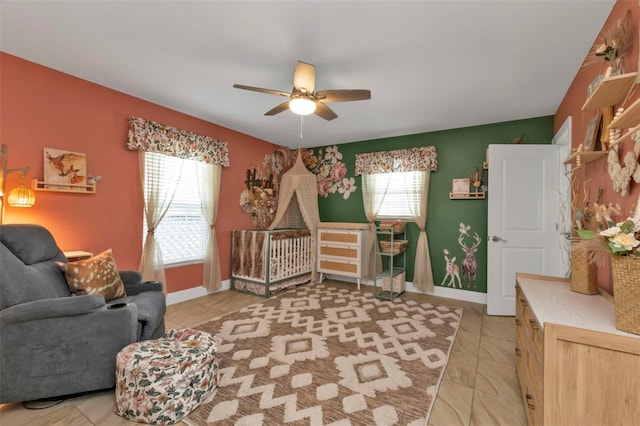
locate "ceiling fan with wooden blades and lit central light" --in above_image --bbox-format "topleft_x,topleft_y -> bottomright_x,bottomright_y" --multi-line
233,61 -> 371,120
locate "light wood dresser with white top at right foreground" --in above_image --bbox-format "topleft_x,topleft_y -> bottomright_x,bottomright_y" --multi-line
516,274 -> 640,426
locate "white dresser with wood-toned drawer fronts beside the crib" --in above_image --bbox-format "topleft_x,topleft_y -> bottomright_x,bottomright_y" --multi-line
316,222 -> 370,289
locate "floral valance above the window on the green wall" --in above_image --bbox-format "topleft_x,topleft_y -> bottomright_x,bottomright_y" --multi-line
355,146 -> 438,175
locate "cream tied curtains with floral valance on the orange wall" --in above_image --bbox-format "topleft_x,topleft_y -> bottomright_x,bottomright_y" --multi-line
127,117 -> 229,292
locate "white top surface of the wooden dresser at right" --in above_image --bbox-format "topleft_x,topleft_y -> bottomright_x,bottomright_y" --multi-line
516,274 -> 640,343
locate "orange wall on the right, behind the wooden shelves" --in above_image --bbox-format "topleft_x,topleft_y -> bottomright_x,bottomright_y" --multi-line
554,0 -> 640,293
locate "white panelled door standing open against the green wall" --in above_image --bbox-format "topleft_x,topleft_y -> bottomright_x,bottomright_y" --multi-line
487,145 -> 560,315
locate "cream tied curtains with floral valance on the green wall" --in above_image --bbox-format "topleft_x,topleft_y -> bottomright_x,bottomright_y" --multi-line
355,146 -> 438,292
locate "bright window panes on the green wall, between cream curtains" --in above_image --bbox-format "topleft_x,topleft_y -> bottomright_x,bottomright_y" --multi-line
372,171 -> 424,220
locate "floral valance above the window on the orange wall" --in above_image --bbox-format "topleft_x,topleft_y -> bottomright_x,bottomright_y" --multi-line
127,117 -> 229,167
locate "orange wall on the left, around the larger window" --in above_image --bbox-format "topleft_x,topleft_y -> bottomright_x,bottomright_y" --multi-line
0,53 -> 273,292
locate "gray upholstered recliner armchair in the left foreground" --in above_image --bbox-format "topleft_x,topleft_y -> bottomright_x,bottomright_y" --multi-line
0,225 -> 166,403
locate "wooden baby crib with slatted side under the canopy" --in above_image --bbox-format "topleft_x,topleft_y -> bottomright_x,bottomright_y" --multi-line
231,229 -> 313,297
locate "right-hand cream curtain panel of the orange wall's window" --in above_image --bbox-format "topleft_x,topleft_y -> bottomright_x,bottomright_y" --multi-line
196,162 -> 222,291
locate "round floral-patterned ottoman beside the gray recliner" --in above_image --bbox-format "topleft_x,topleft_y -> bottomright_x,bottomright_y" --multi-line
114,329 -> 222,424
